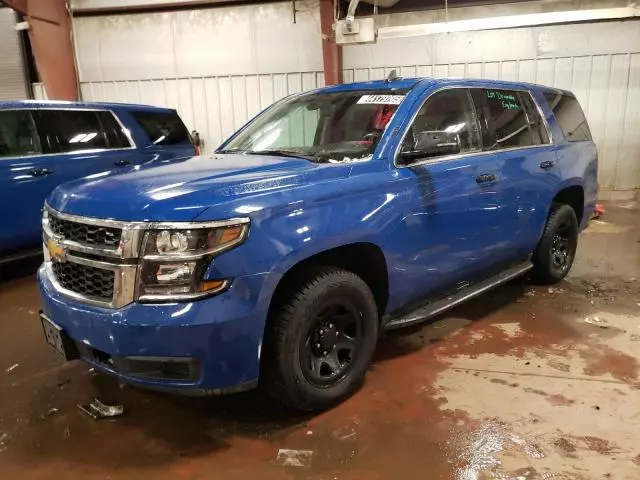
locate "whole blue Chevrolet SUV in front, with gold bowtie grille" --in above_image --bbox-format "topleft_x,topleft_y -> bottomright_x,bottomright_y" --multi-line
38,79 -> 597,410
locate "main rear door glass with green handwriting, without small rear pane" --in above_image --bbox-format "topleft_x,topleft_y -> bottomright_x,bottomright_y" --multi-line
482,90 -> 537,150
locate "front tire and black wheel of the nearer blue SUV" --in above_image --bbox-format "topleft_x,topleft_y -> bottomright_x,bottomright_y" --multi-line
261,268 -> 379,411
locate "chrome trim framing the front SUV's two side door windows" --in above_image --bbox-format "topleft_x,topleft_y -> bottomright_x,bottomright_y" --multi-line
393,85 -> 553,168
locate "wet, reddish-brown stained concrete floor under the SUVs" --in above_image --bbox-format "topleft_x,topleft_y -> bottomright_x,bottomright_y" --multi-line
0,204 -> 640,480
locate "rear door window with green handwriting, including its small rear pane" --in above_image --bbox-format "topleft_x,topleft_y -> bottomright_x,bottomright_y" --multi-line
474,89 -> 549,150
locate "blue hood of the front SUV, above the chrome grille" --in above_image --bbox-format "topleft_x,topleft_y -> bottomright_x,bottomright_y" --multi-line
48,154 -> 349,221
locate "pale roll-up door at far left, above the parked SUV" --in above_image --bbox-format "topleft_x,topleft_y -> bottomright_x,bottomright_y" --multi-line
0,8 -> 29,100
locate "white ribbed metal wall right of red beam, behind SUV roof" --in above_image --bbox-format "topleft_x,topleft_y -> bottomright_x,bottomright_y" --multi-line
344,20 -> 640,190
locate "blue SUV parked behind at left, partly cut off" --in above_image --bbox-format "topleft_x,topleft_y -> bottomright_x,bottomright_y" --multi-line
0,101 -> 195,263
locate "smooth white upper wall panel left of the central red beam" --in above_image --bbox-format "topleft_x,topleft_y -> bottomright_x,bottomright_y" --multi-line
73,0 -> 322,82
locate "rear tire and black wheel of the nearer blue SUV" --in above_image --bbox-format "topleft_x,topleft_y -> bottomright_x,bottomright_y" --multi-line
531,204 -> 579,285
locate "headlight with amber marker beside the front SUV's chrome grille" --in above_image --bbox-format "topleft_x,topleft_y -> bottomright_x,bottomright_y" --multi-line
138,221 -> 249,302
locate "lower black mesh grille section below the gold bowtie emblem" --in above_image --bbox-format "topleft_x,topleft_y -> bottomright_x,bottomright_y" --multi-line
51,262 -> 115,301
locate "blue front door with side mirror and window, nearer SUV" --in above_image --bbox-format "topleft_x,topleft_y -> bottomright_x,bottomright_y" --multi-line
394,88 -> 508,303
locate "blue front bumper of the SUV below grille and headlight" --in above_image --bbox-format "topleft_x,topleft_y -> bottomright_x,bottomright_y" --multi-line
38,267 -> 266,394
